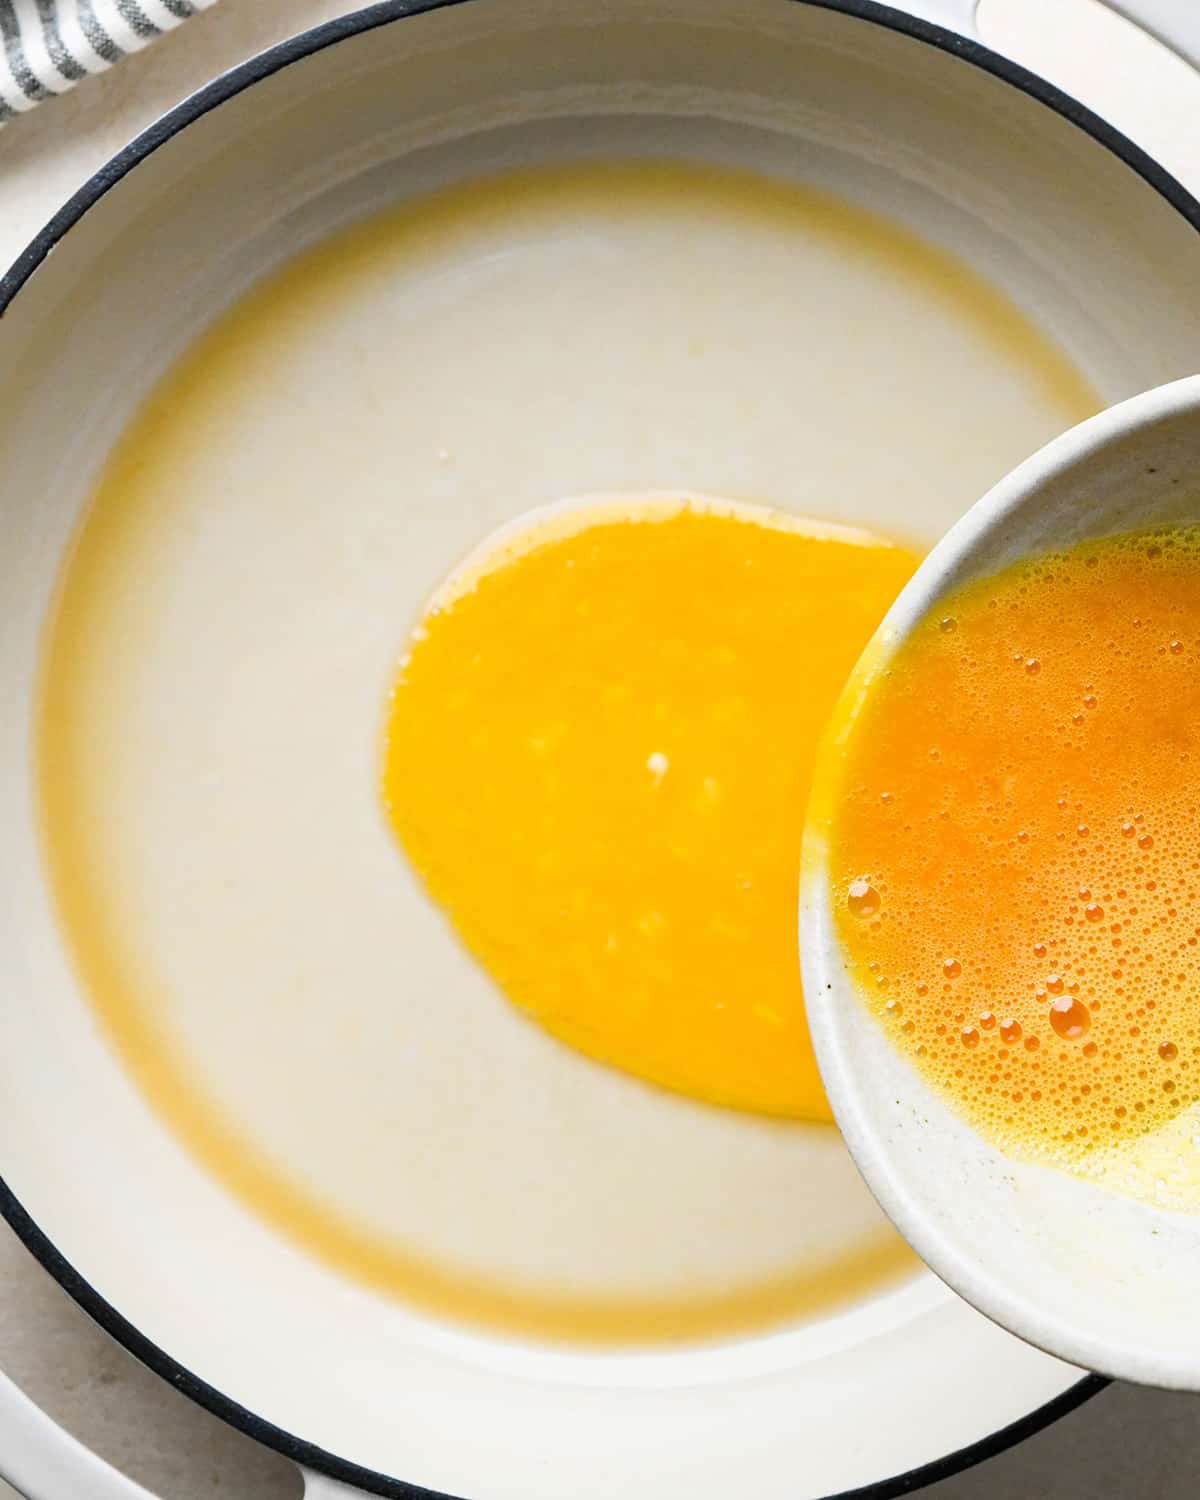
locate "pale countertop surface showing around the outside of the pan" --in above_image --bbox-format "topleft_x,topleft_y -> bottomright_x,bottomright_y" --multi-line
0,0 -> 1200,1500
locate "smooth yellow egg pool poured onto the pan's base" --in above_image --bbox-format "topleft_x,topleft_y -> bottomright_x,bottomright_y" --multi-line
384,500 -> 915,1121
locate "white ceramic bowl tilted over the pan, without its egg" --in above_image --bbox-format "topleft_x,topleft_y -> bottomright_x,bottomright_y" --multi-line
801,377 -> 1200,1391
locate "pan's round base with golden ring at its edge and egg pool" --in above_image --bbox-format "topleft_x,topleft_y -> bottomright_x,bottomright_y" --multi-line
38,162 -> 1095,1341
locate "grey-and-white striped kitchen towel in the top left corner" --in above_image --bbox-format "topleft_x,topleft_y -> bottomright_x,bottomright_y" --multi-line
0,0 -> 216,126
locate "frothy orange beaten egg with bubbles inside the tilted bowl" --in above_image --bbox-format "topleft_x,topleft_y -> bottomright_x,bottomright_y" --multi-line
830,530 -> 1200,1163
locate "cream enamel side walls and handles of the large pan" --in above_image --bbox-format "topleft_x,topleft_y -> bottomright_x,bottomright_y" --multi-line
0,0 -> 1200,1500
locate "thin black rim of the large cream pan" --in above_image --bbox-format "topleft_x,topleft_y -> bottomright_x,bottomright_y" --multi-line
0,0 -> 1200,1500
